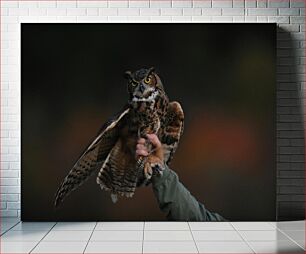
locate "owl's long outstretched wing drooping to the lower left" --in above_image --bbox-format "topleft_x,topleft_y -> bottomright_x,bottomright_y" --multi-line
54,106 -> 130,207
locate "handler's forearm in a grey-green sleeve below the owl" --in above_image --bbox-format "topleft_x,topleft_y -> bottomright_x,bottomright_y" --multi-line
152,166 -> 226,221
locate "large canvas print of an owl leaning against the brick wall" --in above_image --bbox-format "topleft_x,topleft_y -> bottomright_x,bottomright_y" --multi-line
21,24 -> 276,221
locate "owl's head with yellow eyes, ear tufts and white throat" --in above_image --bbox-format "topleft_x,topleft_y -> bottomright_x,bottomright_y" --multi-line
124,67 -> 164,102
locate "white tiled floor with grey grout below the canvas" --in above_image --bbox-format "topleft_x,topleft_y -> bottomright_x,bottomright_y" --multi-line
0,218 -> 305,254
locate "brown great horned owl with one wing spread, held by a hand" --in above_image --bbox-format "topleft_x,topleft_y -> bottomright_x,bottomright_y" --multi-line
55,67 -> 184,206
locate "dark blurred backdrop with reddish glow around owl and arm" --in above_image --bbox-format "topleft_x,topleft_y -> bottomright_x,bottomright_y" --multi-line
21,24 -> 276,221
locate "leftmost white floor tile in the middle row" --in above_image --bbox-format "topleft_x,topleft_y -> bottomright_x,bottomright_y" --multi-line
1,230 -> 47,242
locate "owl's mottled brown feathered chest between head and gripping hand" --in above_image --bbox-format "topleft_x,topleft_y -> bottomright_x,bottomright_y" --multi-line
129,96 -> 169,136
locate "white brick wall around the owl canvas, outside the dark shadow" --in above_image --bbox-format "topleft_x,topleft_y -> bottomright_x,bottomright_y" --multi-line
0,0 -> 305,216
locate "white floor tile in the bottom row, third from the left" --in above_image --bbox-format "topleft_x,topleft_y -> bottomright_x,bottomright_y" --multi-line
85,242 -> 142,254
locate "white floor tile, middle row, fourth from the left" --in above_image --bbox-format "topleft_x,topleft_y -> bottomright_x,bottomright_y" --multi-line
144,230 -> 193,242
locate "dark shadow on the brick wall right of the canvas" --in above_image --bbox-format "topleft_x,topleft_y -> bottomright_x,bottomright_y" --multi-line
276,27 -> 305,220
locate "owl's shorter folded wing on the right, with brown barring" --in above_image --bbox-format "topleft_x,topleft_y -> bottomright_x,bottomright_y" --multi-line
161,101 -> 184,164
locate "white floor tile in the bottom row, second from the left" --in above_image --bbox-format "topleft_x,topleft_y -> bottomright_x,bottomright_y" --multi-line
31,242 -> 87,253
